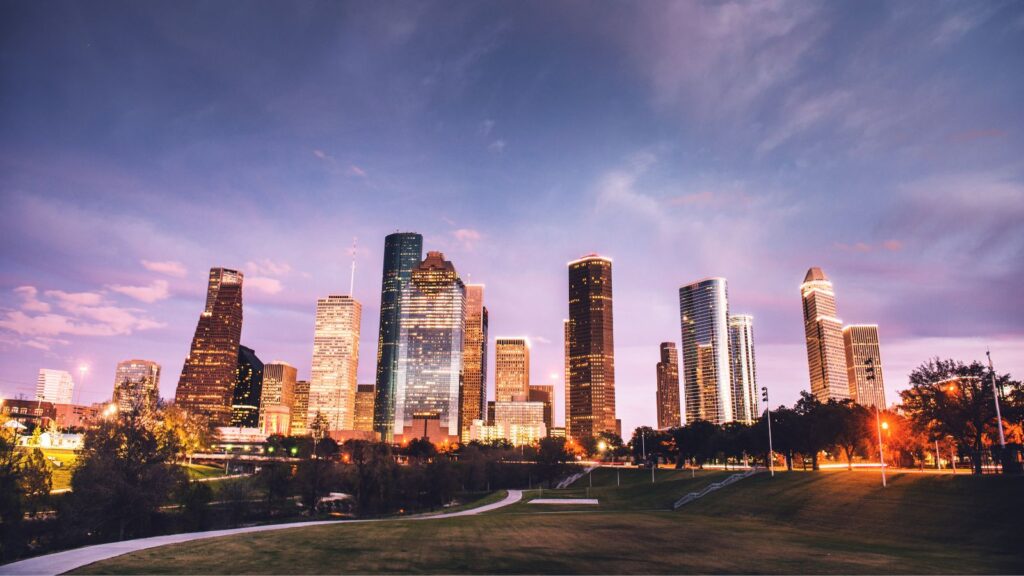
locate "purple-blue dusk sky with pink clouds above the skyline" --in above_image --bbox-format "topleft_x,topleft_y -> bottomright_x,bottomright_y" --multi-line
0,0 -> 1024,429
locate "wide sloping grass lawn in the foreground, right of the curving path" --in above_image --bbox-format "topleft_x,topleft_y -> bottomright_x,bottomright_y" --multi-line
72,469 -> 1024,574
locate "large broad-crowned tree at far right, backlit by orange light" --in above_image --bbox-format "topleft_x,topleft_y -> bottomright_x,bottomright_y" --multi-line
900,358 -> 1021,475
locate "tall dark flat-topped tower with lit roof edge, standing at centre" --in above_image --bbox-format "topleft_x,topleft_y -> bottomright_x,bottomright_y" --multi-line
566,254 -> 615,440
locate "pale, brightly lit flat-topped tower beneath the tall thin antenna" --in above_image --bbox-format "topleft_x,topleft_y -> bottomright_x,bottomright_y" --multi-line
306,296 -> 362,430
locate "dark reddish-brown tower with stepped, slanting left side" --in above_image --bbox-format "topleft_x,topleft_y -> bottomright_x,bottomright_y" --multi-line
174,268 -> 244,426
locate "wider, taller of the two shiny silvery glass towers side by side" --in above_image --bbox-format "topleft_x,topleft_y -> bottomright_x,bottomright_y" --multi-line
679,278 -> 734,424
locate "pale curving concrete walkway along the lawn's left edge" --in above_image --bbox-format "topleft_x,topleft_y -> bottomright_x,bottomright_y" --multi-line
0,490 -> 522,575
